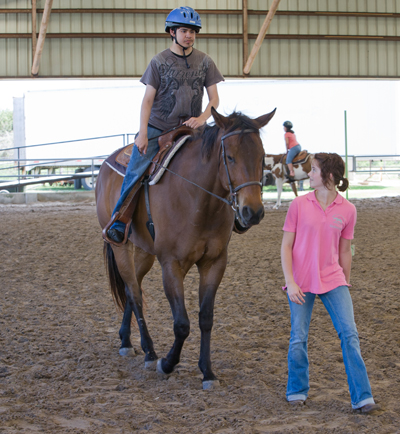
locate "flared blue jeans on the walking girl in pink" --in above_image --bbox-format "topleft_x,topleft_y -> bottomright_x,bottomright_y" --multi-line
286,286 -> 374,409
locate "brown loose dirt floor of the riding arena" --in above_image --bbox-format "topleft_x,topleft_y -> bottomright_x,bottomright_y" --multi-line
0,197 -> 400,434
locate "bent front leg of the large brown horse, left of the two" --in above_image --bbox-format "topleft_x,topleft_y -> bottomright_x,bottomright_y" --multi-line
157,261 -> 190,375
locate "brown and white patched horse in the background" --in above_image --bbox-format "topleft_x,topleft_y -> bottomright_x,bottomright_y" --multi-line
264,150 -> 313,209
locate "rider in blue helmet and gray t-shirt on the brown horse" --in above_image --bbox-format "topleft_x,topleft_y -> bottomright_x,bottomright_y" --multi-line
107,7 -> 224,243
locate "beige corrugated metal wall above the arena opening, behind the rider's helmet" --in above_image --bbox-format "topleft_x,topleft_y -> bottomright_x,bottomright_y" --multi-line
0,0 -> 400,78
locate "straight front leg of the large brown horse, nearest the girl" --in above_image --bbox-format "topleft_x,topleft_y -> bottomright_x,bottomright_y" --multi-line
198,250 -> 227,389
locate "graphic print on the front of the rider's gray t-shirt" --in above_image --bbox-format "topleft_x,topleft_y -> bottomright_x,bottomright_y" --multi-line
158,57 -> 206,121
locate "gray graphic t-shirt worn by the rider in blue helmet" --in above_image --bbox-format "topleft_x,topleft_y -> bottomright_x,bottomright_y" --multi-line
140,49 -> 224,131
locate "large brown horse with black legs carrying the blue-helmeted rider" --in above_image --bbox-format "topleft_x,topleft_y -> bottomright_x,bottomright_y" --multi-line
96,109 -> 275,389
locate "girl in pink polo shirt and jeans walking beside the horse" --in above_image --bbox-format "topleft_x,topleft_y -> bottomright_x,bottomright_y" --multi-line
281,153 -> 379,413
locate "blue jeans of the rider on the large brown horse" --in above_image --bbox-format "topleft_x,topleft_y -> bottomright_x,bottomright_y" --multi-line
111,125 -> 162,232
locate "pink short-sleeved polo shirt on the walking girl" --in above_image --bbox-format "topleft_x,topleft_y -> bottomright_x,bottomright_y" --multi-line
283,191 -> 357,294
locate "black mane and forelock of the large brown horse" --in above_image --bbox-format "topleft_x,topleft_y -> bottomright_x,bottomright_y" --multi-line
199,112 -> 259,159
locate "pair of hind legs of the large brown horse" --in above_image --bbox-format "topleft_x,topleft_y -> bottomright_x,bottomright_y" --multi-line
113,242 -> 157,368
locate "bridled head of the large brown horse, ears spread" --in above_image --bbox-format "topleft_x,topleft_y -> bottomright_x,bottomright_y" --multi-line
211,108 -> 276,227
